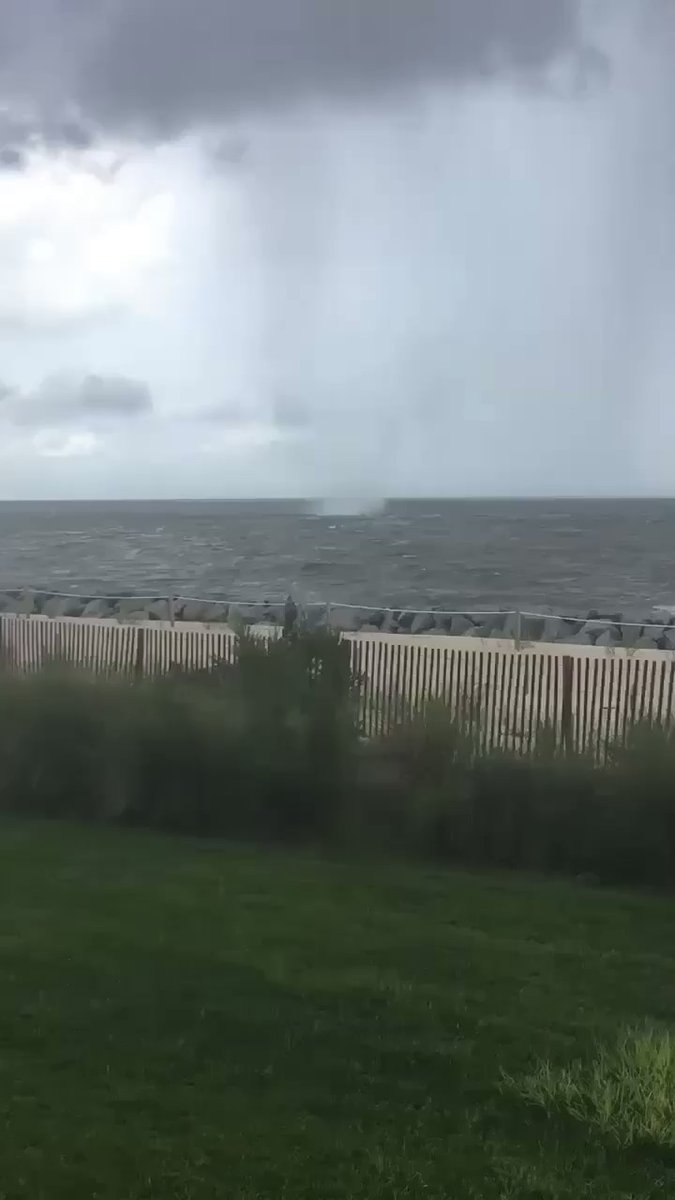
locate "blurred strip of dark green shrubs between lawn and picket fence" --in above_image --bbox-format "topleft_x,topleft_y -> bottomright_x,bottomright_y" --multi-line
0,632 -> 675,886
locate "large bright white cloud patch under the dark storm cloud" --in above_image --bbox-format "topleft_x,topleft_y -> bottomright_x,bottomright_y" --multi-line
0,144 -> 174,329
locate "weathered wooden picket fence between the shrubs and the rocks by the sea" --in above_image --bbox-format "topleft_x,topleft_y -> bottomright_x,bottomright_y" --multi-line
0,614 -> 675,756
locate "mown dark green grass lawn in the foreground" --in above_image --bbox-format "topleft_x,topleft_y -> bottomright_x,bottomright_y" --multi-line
0,824 -> 675,1200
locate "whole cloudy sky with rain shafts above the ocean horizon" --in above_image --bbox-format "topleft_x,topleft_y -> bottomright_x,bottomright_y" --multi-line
0,0 -> 675,499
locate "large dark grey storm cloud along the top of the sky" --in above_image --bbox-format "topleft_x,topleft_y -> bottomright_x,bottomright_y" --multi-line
0,0 -> 584,140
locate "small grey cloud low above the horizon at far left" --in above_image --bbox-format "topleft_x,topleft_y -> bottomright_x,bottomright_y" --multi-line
0,374 -> 153,427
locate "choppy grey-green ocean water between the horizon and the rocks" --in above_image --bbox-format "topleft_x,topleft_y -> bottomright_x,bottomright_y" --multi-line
0,499 -> 675,619
